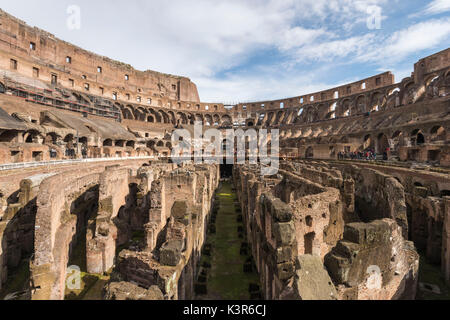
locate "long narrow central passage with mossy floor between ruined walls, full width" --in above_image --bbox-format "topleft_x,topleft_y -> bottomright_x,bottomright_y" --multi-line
196,181 -> 260,300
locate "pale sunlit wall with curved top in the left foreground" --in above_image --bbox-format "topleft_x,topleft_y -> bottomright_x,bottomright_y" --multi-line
30,171 -> 100,300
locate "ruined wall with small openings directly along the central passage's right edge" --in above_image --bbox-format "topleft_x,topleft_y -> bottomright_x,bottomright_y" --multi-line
234,167 -> 343,299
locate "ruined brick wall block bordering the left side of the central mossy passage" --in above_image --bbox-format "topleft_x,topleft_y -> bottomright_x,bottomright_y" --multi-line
105,165 -> 220,300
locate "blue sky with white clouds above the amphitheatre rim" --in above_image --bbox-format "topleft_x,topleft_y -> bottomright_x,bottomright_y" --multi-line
0,0 -> 450,103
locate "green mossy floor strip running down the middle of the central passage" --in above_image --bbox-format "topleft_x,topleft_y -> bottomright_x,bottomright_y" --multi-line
201,183 -> 259,300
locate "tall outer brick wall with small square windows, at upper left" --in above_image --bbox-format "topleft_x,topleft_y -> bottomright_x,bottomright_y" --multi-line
0,10 -> 200,102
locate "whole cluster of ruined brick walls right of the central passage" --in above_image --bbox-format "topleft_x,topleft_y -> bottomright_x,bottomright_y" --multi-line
233,162 -> 419,300
